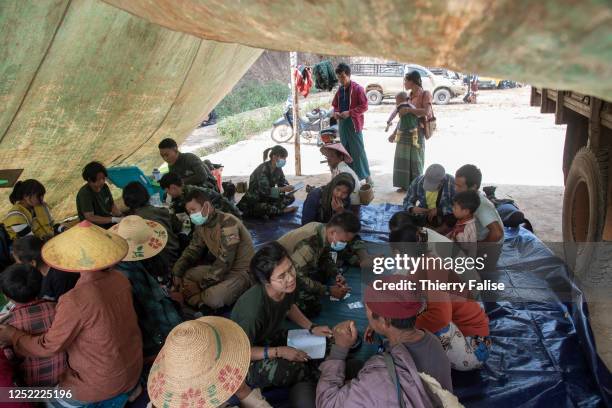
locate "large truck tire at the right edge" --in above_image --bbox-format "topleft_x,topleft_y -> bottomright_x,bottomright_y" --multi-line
563,147 -> 608,242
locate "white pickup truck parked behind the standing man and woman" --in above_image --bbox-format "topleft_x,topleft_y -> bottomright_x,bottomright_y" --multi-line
351,63 -> 467,105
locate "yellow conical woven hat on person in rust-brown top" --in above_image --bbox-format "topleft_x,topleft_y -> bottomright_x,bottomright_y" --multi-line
41,221 -> 128,272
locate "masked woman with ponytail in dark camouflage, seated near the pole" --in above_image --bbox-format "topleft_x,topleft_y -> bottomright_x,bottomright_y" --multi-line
238,146 -> 295,218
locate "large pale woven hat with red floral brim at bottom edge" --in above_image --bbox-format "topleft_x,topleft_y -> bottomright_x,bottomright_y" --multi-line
147,316 -> 251,407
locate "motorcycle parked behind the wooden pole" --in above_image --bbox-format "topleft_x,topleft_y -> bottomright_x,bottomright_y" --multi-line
270,106 -> 334,143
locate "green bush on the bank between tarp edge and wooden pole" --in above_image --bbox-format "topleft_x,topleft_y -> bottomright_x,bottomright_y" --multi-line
215,81 -> 289,118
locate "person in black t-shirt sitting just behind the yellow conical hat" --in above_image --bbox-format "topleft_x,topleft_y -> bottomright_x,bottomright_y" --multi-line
76,161 -> 122,228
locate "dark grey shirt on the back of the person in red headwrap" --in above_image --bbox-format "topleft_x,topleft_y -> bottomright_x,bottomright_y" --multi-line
403,331 -> 453,392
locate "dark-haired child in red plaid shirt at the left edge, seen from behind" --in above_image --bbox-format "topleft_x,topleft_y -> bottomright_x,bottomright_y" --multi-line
0,264 -> 67,387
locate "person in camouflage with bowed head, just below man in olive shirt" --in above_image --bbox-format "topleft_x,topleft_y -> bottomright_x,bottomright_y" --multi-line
159,173 -> 242,218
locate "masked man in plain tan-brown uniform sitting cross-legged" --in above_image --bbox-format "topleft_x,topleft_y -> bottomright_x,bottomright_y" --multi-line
172,190 -> 254,310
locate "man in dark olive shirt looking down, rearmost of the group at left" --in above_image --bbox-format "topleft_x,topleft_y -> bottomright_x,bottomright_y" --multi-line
158,138 -> 219,192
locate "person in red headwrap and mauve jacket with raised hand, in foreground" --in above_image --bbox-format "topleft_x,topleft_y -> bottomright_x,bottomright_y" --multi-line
316,277 -> 456,408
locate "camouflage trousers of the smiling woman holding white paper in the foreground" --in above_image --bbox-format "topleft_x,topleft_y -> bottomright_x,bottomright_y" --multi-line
246,331 -> 319,388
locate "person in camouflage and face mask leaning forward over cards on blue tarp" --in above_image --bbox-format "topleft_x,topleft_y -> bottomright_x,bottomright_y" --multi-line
278,212 -> 360,317
